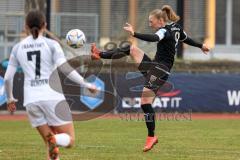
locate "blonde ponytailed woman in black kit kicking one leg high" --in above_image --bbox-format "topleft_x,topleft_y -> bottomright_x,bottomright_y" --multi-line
91,5 -> 209,152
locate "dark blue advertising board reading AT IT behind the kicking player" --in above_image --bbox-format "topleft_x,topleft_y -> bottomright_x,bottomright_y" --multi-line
116,73 -> 240,112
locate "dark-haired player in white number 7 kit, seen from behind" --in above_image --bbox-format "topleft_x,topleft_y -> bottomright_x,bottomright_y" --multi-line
4,10 -> 96,160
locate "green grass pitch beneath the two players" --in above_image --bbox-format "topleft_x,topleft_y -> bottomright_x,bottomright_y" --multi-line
0,119 -> 240,160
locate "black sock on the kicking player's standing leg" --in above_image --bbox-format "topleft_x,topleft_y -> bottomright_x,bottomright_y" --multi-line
141,104 -> 155,137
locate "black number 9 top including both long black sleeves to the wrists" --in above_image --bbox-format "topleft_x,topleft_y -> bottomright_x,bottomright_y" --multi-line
133,23 -> 203,70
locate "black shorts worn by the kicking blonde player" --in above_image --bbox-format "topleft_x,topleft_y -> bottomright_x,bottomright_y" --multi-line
138,54 -> 170,93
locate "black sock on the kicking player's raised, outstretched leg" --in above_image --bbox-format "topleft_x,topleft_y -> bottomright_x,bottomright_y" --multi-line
100,46 -> 130,59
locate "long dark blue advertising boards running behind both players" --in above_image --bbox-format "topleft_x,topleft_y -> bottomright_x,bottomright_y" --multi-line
0,72 -> 240,112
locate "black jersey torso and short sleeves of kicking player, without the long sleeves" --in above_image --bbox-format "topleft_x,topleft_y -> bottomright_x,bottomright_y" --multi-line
154,23 -> 187,69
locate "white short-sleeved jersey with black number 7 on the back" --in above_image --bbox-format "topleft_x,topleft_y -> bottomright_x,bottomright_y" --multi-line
9,36 -> 66,106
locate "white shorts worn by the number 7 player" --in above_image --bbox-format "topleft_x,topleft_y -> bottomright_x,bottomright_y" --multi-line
26,100 -> 72,127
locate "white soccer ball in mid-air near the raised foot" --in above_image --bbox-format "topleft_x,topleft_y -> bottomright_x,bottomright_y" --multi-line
66,29 -> 86,48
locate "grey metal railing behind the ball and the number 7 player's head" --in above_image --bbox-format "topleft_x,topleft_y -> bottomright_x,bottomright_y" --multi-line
0,12 -> 99,60
